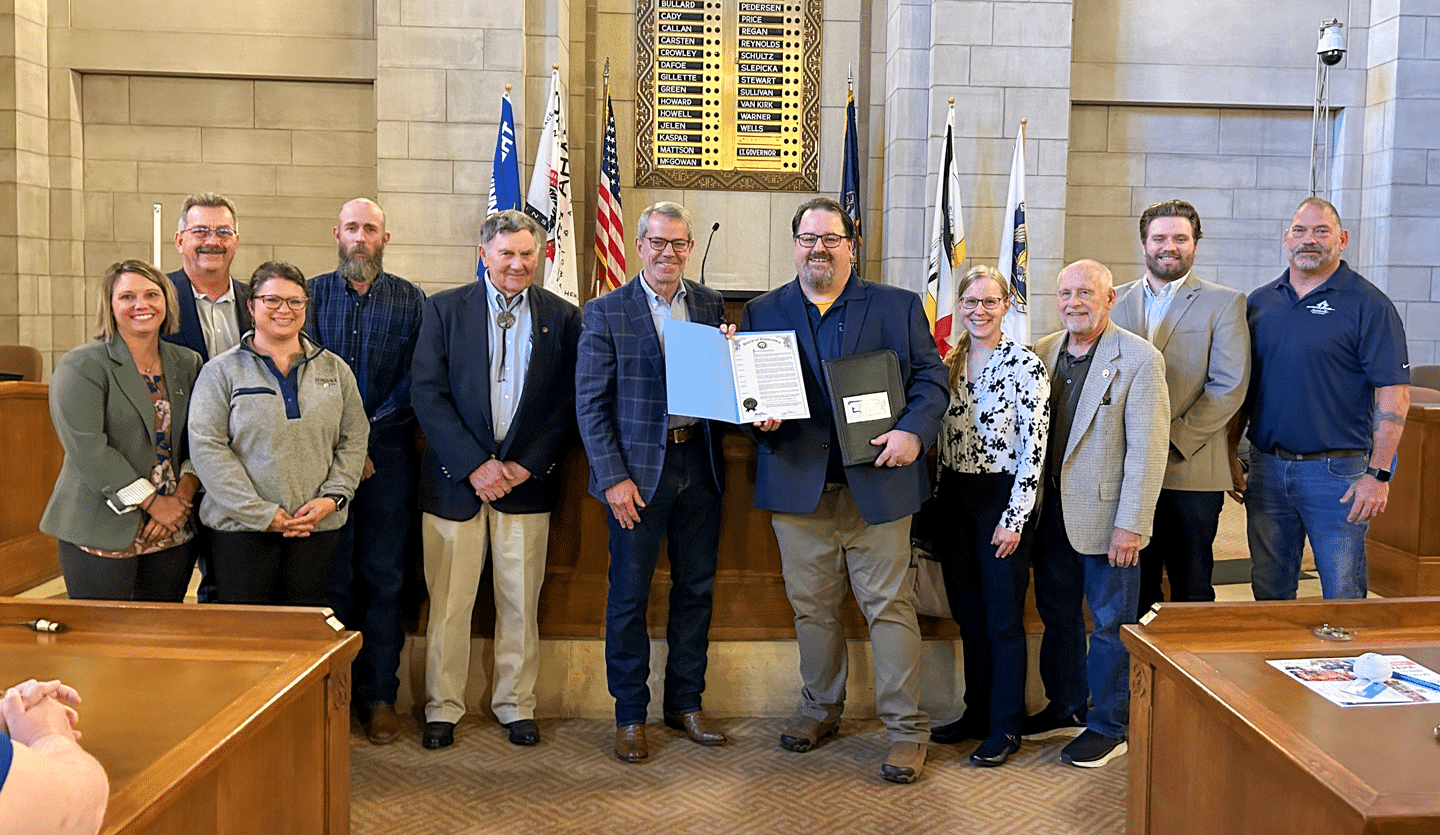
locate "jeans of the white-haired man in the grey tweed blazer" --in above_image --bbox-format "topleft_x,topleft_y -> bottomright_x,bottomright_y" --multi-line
1034,484 -> 1140,739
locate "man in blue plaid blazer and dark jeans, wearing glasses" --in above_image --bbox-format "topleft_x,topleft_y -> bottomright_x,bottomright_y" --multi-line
575,202 -> 726,763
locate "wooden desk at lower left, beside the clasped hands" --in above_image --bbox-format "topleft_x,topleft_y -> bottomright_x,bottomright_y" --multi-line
0,597 -> 360,835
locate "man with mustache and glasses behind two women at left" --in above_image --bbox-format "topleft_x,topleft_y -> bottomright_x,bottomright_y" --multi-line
164,191 -> 255,360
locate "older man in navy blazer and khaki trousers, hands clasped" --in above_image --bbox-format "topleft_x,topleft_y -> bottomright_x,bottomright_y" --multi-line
410,210 -> 580,749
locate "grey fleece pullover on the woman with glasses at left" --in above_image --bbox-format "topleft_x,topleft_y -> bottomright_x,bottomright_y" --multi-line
189,333 -> 370,531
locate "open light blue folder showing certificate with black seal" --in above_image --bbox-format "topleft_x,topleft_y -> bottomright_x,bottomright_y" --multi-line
665,320 -> 809,423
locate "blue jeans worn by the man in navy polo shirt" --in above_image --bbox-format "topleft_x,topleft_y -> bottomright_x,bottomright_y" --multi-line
1246,451 -> 1369,600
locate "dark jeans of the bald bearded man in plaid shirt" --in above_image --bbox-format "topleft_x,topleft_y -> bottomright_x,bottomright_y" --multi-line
327,426 -> 416,707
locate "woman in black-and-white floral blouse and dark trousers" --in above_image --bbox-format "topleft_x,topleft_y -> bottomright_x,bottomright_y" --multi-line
930,266 -> 1050,766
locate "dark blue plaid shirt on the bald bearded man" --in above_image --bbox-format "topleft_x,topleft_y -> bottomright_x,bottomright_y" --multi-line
305,272 -> 425,425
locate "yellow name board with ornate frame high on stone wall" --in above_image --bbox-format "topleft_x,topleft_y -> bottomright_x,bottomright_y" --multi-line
635,0 -> 824,191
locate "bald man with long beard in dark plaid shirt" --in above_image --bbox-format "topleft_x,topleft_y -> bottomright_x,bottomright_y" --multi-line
305,197 -> 425,744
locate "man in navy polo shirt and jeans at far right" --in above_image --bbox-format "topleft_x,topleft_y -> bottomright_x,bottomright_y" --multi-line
1236,197 -> 1410,600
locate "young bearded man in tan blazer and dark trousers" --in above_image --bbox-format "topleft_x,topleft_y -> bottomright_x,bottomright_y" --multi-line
1110,200 -> 1250,615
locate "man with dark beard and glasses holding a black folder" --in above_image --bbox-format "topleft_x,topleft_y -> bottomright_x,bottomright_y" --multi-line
740,197 -> 949,783
